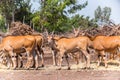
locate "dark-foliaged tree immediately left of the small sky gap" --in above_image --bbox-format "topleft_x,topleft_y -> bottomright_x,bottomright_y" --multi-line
15,0 -> 33,24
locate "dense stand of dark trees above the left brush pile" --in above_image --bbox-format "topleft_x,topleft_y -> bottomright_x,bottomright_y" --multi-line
0,0 -> 32,28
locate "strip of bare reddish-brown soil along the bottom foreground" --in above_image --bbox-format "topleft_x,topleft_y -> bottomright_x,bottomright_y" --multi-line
0,70 -> 120,80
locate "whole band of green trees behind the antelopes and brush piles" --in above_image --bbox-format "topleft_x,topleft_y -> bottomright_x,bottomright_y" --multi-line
0,0 -> 111,32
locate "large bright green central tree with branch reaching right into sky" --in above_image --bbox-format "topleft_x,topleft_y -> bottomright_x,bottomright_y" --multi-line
32,0 -> 87,32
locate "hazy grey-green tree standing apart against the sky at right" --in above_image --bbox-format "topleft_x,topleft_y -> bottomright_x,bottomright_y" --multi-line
94,6 -> 111,25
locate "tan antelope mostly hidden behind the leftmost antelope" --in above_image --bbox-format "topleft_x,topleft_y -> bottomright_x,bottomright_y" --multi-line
0,34 -> 44,69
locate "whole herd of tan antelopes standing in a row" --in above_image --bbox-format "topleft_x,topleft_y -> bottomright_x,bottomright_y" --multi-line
0,28 -> 120,70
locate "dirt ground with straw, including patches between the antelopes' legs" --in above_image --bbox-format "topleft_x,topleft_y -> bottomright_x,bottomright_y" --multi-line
0,49 -> 120,80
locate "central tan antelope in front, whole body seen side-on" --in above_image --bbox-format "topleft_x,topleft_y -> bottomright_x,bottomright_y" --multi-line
48,36 -> 92,69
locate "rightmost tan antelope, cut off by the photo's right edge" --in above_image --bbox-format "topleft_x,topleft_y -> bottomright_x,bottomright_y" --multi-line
91,36 -> 120,67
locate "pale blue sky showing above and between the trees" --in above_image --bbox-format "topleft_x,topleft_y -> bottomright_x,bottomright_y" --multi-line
32,0 -> 120,24
